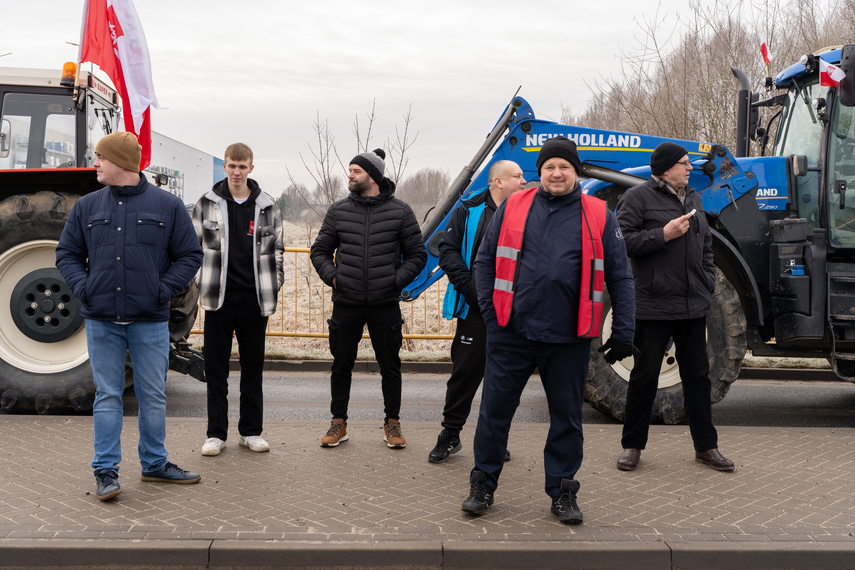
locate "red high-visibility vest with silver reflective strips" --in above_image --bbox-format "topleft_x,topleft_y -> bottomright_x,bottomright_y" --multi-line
493,188 -> 606,338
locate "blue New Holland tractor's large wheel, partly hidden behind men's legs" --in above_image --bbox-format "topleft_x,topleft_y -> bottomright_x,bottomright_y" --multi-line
585,269 -> 746,424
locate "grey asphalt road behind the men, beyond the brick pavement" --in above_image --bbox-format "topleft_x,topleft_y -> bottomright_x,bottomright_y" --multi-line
125,372 -> 855,427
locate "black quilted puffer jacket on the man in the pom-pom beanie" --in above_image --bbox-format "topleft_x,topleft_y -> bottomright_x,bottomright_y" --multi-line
311,178 -> 427,306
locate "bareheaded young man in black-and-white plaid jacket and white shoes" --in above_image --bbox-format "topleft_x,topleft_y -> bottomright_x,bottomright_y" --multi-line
193,143 -> 284,456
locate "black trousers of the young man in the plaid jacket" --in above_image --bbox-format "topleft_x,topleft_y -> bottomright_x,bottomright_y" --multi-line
202,290 -> 267,441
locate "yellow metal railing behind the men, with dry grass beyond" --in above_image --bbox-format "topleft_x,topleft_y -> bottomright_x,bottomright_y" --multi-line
190,247 -> 454,340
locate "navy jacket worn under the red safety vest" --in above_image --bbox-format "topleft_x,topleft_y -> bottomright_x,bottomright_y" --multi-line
475,184 -> 635,344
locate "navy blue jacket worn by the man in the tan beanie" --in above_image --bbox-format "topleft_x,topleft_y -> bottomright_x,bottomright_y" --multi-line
56,176 -> 202,322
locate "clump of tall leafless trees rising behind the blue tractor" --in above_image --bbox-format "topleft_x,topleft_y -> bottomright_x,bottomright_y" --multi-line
562,0 -> 855,155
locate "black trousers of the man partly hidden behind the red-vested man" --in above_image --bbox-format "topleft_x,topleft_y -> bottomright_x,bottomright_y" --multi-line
442,307 -> 487,435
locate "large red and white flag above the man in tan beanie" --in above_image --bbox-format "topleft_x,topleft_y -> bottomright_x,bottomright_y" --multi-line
77,0 -> 160,169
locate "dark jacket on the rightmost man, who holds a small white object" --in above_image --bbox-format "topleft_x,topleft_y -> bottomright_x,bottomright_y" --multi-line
616,177 -> 715,321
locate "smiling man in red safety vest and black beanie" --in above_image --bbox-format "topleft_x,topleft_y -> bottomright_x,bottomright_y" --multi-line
462,137 -> 635,524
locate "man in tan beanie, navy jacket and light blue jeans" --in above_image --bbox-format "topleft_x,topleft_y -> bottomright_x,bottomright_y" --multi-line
56,133 -> 202,501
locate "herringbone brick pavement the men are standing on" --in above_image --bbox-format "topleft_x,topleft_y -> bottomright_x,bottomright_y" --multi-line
0,415 -> 855,569
